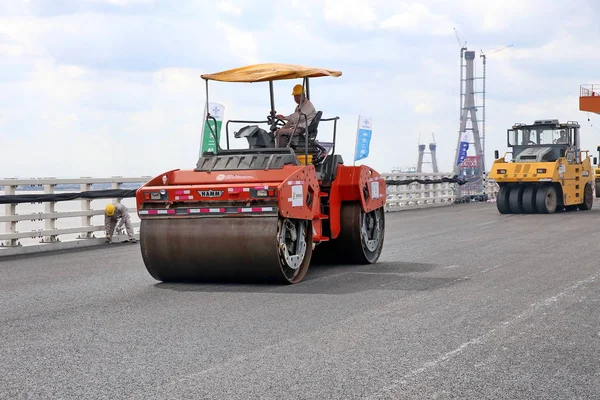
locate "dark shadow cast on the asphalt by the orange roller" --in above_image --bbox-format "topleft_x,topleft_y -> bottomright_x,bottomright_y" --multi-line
155,262 -> 455,295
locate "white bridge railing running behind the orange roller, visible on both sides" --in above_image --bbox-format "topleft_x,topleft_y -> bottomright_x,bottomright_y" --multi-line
0,173 -> 497,255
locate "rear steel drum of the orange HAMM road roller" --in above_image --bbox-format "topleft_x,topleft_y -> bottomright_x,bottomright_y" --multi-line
334,203 -> 385,264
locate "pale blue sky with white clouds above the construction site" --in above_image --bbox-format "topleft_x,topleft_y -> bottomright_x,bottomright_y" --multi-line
0,0 -> 600,177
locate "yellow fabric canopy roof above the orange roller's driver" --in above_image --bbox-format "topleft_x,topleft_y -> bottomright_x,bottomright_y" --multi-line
201,64 -> 342,83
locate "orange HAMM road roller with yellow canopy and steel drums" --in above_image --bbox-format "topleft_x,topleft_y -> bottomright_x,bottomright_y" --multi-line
136,64 -> 386,284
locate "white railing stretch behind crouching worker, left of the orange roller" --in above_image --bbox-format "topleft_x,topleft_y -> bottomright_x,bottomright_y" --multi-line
0,177 -> 150,255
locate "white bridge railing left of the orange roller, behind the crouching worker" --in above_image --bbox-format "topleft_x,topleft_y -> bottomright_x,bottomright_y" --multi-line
0,176 -> 150,254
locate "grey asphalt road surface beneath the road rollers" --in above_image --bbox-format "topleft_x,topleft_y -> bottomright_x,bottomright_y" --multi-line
0,203 -> 600,400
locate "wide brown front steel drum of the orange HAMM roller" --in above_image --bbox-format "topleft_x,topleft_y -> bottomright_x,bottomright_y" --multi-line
140,216 -> 312,284
